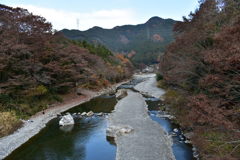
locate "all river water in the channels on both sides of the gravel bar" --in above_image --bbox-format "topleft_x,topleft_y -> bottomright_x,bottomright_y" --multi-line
6,79 -> 194,160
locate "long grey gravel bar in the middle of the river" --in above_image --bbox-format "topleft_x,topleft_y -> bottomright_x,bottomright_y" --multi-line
107,90 -> 175,160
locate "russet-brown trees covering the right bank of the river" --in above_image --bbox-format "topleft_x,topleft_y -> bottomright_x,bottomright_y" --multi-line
159,0 -> 240,160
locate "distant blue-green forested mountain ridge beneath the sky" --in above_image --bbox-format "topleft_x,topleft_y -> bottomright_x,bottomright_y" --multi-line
60,17 -> 176,64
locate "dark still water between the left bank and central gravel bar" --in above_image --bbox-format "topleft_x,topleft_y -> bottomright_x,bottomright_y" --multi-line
6,97 -> 116,160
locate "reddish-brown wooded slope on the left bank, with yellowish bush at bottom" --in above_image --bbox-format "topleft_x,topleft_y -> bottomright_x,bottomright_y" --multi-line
0,5 -> 133,137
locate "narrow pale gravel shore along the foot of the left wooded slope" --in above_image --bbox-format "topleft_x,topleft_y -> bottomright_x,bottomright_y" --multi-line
0,82 -> 125,159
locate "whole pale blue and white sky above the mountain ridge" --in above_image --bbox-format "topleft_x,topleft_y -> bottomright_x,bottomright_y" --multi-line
0,0 -> 198,30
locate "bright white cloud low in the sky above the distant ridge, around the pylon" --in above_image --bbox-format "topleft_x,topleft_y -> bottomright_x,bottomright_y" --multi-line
15,5 -> 136,30
